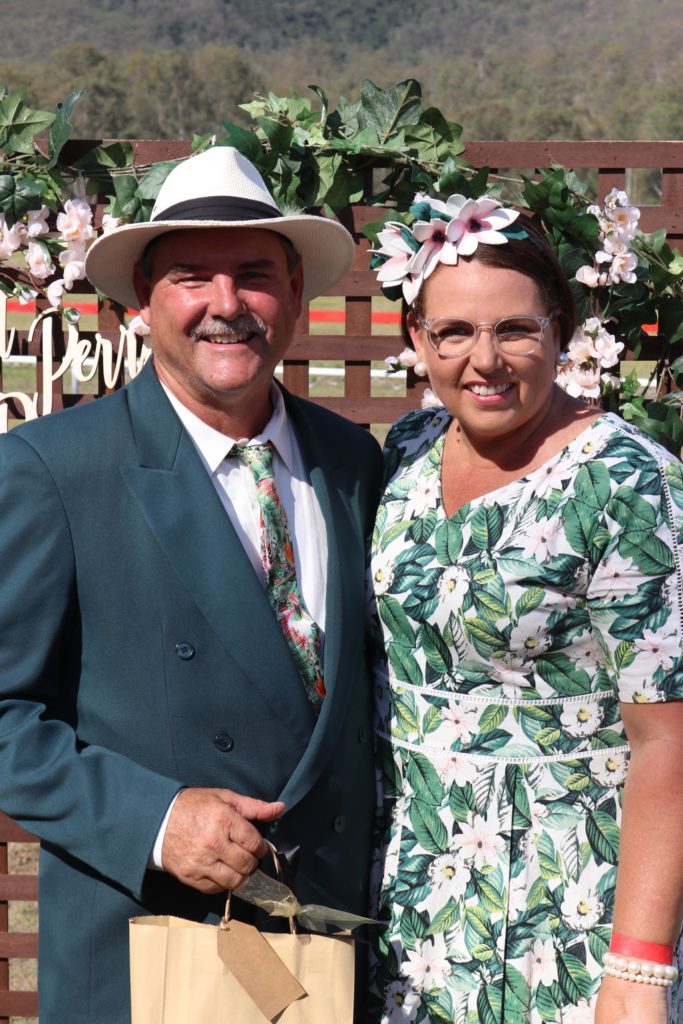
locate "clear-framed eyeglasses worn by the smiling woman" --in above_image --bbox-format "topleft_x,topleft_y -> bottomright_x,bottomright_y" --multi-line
420,311 -> 556,358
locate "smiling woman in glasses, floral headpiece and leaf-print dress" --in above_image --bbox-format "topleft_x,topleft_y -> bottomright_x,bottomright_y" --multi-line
372,197 -> 683,1024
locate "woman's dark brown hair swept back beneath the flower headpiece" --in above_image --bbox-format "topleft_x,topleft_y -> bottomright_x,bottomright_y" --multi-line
400,211 -> 577,349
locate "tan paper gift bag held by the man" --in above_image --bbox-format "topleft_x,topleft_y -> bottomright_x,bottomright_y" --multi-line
130,916 -> 354,1024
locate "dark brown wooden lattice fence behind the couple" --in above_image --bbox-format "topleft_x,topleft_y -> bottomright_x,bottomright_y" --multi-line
0,141 -> 683,1024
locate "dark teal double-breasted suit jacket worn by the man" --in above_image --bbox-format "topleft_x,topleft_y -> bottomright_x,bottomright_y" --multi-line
0,365 -> 381,1024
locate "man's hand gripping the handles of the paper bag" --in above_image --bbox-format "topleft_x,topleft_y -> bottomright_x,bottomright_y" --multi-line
162,788 -> 285,893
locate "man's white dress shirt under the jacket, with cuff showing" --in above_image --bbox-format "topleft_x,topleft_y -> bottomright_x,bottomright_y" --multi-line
150,383 -> 328,869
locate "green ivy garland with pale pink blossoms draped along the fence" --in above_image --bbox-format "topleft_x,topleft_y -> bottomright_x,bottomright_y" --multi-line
0,79 -> 683,454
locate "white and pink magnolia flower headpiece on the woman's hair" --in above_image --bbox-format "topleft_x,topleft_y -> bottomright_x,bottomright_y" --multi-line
371,194 -> 527,305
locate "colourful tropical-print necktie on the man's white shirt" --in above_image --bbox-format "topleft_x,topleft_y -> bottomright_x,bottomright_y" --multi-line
231,441 -> 325,713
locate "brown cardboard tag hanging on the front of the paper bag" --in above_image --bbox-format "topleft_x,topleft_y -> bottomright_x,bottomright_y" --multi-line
218,921 -> 306,1021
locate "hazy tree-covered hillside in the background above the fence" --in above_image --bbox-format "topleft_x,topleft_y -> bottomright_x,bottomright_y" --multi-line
0,0 -> 683,138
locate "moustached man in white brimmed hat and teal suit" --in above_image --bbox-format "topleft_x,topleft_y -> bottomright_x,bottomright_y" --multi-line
0,147 -> 379,1024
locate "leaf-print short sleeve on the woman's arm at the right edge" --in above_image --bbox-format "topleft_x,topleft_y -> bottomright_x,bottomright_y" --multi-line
587,449 -> 683,703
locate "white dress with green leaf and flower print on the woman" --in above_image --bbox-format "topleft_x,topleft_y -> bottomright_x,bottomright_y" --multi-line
371,410 -> 683,1024
